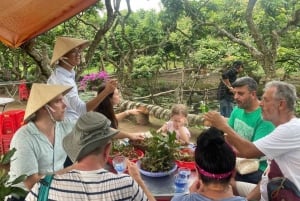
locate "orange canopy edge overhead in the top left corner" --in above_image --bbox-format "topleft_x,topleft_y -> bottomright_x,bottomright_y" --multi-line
0,0 -> 97,47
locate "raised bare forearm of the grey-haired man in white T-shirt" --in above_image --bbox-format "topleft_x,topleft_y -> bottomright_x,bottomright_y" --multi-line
204,112 -> 264,158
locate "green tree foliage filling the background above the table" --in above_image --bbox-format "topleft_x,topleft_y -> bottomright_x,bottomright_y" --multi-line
0,0 -> 300,87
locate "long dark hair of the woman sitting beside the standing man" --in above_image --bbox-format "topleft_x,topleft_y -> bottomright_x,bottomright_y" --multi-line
94,84 -> 118,129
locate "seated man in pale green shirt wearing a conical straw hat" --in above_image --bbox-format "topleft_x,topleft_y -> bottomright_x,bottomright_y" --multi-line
9,83 -> 75,200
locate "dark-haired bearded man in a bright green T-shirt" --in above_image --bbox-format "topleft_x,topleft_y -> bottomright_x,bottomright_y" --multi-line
228,77 -> 274,184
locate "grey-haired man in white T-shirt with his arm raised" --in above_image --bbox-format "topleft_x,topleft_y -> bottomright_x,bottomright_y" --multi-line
204,81 -> 300,201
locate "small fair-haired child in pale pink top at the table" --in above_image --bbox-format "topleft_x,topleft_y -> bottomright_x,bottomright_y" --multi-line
157,104 -> 191,144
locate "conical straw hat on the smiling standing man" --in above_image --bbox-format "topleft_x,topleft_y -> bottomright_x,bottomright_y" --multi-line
50,36 -> 89,66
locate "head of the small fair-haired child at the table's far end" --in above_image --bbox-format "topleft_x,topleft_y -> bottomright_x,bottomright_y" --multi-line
170,104 -> 188,129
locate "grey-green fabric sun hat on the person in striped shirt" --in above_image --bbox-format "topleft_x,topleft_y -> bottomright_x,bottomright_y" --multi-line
63,112 -> 119,162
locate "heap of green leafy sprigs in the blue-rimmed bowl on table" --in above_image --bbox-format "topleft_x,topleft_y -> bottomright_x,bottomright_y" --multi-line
141,131 -> 180,172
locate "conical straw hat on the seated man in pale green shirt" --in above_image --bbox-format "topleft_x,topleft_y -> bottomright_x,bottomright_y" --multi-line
24,83 -> 72,122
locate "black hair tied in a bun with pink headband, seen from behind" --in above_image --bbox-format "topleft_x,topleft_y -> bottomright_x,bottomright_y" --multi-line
195,127 -> 236,184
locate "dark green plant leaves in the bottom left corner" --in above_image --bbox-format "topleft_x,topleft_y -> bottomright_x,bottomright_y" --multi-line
0,149 -> 27,200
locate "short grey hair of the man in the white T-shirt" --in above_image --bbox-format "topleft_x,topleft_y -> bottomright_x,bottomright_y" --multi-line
264,81 -> 297,111
